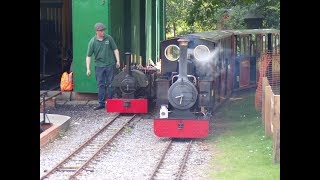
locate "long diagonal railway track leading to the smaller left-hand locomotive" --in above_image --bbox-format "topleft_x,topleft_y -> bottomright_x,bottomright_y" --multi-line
40,114 -> 139,180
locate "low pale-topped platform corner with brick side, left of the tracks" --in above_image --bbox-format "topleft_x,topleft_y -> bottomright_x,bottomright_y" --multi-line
40,113 -> 71,148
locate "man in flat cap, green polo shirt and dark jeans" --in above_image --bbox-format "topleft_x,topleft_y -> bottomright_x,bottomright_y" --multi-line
86,23 -> 120,110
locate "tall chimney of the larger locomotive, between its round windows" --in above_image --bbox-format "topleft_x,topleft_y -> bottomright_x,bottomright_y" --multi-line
178,39 -> 189,80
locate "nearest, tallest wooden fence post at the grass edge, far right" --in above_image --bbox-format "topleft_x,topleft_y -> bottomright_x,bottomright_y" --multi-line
272,95 -> 280,163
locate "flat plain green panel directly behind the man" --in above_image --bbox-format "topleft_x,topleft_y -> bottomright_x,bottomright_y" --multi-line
72,0 -> 110,92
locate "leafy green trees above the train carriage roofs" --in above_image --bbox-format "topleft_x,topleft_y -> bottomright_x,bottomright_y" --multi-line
166,0 -> 280,37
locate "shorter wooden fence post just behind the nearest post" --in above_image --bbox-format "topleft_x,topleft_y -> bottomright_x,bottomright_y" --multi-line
264,86 -> 272,136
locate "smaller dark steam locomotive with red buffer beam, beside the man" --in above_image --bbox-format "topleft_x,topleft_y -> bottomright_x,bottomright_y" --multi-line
106,52 -> 156,113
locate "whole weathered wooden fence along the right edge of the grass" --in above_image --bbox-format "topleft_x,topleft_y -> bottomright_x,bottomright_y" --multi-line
261,77 -> 280,163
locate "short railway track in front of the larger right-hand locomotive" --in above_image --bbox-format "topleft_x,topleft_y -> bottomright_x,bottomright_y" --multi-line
150,139 -> 192,180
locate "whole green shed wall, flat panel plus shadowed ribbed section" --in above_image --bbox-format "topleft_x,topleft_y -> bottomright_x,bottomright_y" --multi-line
72,0 -> 165,93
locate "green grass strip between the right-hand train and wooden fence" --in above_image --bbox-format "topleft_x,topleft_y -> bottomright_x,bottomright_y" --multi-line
209,91 -> 280,180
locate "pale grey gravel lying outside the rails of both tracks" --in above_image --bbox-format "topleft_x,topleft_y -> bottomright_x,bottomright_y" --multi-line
40,103 -> 212,180
